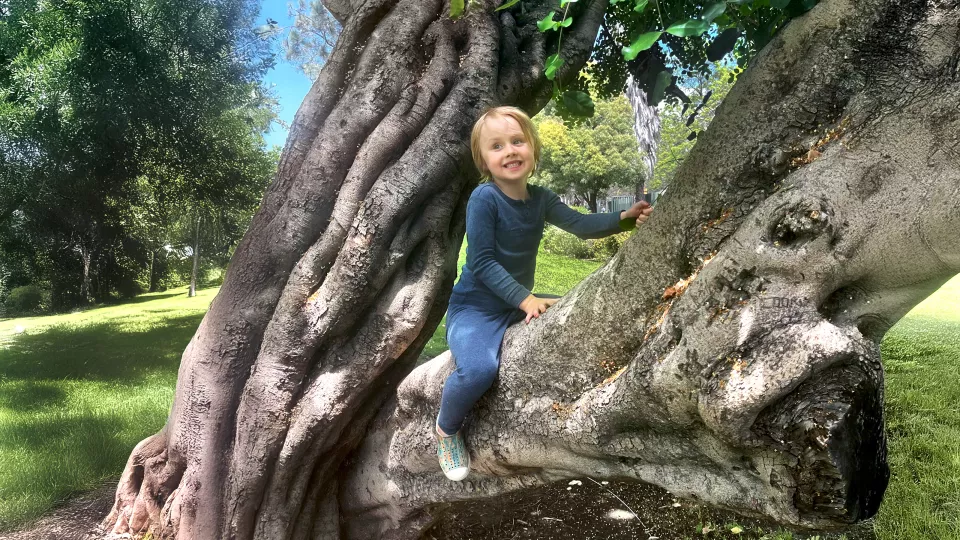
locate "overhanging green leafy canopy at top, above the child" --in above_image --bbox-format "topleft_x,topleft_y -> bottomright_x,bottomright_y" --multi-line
468,0 -> 818,121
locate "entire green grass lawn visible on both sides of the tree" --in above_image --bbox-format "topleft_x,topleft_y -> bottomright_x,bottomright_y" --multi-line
0,252 -> 960,540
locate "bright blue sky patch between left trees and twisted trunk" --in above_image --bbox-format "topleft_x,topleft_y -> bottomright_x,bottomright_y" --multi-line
257,0 -> 310,147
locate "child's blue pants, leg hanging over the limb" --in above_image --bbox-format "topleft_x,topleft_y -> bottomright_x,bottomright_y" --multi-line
437,294 -> 559,435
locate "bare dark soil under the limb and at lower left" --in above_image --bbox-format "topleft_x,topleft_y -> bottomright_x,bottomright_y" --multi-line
0,478 -> 876,540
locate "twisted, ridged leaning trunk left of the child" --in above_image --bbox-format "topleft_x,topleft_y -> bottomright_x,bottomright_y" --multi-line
107,0 -> 606,540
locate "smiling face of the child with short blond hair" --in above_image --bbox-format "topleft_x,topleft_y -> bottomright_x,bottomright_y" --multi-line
480,116 -> 535,184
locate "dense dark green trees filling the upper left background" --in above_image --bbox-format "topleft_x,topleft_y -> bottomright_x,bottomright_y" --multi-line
0,0 -> 273,308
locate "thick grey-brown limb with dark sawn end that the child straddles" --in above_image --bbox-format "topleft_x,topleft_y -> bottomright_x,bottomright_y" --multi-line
341,1 -> 960,538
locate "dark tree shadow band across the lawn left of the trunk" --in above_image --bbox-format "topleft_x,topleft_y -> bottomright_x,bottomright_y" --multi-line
0,313 -> 203,384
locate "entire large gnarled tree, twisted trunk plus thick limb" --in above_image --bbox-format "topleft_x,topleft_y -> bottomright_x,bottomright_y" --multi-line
107,0 -> 960,540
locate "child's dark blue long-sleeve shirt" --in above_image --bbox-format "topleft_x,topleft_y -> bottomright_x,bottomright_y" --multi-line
451,182 -> 621,308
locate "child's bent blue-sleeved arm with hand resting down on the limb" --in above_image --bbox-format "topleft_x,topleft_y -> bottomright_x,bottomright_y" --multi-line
467,193 -> 530,307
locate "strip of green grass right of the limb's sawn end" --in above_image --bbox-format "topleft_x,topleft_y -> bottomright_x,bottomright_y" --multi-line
876,276 -> 960,540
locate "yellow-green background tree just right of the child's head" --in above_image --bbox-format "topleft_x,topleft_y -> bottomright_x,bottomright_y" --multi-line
537,95 -> 644,212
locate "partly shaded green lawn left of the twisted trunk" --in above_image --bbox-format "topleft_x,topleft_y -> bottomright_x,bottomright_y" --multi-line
0,289 -> 216,530
